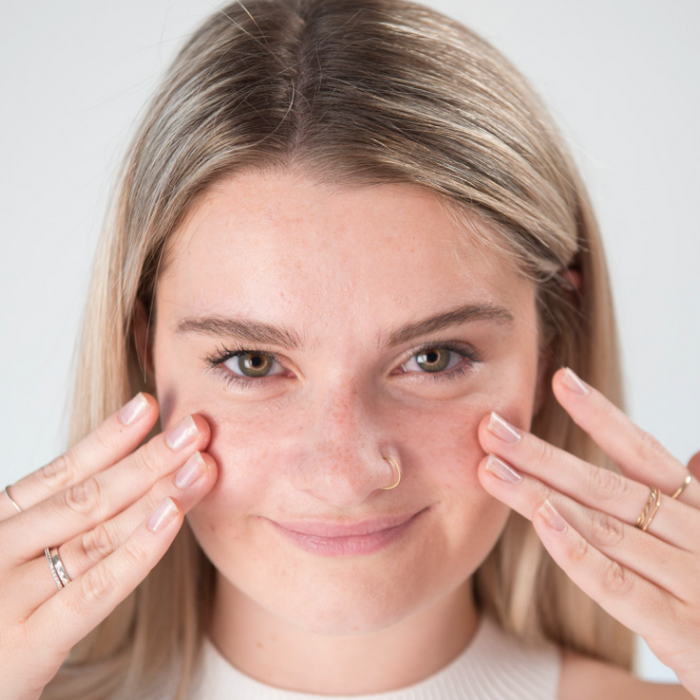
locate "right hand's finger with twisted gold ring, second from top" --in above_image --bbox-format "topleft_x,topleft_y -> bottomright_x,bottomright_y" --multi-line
478,413 -> 700,554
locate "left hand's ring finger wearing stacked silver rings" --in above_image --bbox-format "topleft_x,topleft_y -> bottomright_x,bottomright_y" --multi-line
10,452 -> 217,618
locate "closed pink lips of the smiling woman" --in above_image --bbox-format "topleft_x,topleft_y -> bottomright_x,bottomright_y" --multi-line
268,508 -> 427,557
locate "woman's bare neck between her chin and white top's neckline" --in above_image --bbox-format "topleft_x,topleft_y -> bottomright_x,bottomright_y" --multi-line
209,576 -> 479,695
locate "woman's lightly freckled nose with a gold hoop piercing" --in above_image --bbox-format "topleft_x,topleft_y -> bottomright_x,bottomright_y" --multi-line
289,380 -> 398,509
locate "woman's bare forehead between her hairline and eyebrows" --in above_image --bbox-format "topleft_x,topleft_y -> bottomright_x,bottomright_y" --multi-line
158,171 -> 529,334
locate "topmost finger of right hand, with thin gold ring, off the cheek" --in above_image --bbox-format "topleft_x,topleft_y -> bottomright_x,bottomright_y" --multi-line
552,369 -> 700,508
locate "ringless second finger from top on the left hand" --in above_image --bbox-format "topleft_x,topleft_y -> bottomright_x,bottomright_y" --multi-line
0,416 -> 210,568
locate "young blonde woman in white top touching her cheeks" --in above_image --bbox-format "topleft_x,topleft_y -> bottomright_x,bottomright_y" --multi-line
0,0 -> 700,700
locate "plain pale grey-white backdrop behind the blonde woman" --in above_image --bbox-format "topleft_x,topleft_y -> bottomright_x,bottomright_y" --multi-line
0,0 -> 700,680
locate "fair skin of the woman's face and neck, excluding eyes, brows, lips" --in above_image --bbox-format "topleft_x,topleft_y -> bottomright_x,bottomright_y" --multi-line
148,168 -> 539,694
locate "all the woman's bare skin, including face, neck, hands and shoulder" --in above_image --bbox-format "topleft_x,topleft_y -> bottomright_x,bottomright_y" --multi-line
0,172 -> 700,700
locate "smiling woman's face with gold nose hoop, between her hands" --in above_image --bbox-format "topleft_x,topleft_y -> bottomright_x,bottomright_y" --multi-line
153,172 -> 538,634
